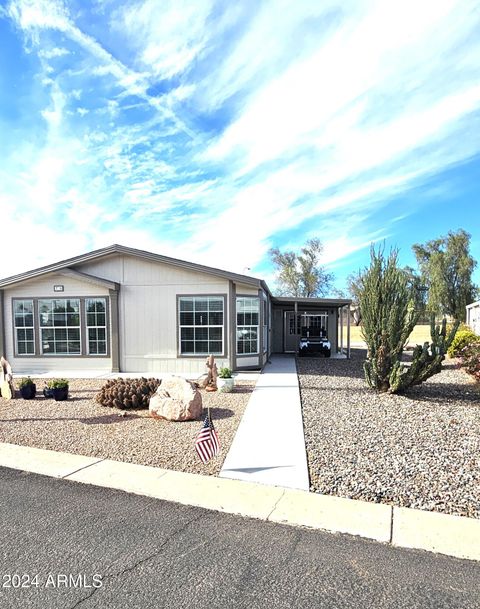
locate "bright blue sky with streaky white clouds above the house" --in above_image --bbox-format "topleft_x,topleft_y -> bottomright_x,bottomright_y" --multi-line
0,0 -> 480,288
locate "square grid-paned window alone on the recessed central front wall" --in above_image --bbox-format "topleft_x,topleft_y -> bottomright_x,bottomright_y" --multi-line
179,296 -> 224,355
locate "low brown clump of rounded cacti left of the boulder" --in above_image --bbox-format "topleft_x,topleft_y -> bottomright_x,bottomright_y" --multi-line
95,377 -> 160,410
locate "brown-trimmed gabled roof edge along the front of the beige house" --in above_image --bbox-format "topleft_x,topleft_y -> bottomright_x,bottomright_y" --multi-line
0,244 -> 270,292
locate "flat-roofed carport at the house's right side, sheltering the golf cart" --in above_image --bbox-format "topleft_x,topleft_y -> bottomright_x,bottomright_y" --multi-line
272,296 -> 352,358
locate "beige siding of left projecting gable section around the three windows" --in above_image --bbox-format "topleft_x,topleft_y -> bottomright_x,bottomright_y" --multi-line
4,273 -> 112,374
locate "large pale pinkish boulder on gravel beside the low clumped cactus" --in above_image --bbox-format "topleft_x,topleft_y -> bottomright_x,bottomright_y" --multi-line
148,376 -> 203,421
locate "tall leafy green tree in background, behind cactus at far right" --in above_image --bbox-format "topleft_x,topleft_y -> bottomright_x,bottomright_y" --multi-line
412,229 -> 477,321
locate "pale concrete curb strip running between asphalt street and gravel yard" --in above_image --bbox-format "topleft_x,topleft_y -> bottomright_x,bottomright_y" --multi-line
0,443 -> 480,561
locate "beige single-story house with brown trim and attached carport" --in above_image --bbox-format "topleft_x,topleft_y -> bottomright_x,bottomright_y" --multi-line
0,245 -> 350,374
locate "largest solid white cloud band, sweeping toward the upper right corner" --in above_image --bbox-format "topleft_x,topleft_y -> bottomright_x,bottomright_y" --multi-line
206,1 -> 480,171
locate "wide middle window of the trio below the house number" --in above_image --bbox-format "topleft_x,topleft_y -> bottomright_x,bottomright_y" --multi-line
38,298 -> 81,355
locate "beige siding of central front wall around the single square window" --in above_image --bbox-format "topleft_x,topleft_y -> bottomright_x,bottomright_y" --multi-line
80,256 -> 230,374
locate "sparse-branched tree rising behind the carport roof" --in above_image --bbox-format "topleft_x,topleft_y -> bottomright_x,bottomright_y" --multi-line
269,239 -> 333,298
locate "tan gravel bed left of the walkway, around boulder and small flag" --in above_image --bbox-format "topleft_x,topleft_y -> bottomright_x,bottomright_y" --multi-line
0,379 -> 254,475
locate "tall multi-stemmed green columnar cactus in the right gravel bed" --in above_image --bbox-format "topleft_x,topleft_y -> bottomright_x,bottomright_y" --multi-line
359,246 -> 458,393
